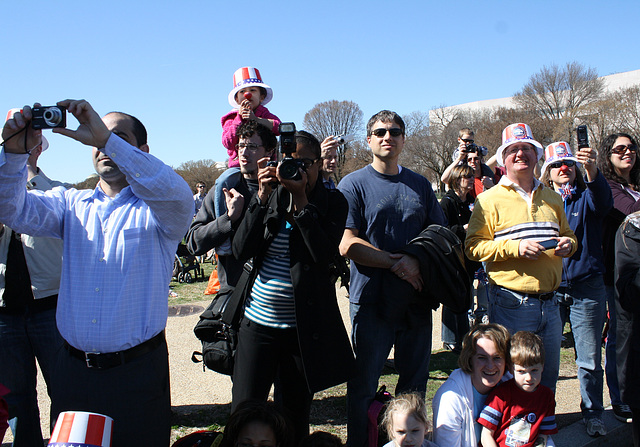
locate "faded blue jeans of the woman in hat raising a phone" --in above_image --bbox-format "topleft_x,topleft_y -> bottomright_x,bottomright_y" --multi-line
556,275 -> 607,418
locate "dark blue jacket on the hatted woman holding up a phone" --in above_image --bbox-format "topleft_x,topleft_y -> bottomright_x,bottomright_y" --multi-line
560,170 -> 613,287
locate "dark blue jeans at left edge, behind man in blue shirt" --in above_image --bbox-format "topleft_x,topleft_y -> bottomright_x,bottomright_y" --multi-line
0,309 -> 62,447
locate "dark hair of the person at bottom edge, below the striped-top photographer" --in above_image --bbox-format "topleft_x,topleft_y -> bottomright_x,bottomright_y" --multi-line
220,400 -> 294,447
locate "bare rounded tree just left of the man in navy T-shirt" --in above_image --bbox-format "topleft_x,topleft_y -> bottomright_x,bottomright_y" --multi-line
303,99 -> 364,182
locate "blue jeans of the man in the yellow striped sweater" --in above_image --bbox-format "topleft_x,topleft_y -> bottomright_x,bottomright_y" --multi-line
489,284 -> 562,392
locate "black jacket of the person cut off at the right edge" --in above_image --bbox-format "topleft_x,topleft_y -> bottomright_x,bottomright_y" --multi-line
615,212 -> 640,408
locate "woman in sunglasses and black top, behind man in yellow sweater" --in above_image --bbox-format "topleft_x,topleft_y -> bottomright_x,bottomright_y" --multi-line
440,164 -> 482,353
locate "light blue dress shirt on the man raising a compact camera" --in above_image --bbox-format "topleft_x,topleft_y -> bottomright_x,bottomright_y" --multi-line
0,134 -> 194,352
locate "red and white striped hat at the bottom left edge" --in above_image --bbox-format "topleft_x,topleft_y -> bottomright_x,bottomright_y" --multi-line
48,411 -> 113,447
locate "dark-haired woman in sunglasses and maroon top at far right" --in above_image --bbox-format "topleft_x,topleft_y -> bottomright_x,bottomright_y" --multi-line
598,133 -> 640,423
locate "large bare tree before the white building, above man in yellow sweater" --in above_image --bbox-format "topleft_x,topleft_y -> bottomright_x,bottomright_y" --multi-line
513,62 -> 604,141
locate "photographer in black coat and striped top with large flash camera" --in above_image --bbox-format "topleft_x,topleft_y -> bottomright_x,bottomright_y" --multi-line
231,123 -> 354,445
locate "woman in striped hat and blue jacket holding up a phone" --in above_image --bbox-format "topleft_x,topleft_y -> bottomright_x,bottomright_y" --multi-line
541,141 -> 613,436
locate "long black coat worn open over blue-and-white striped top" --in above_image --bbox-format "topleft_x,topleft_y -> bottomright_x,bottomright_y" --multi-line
233,181 -> 355,393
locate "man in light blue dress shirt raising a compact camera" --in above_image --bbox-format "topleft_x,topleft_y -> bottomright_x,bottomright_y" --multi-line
0,100 -> 194,447
